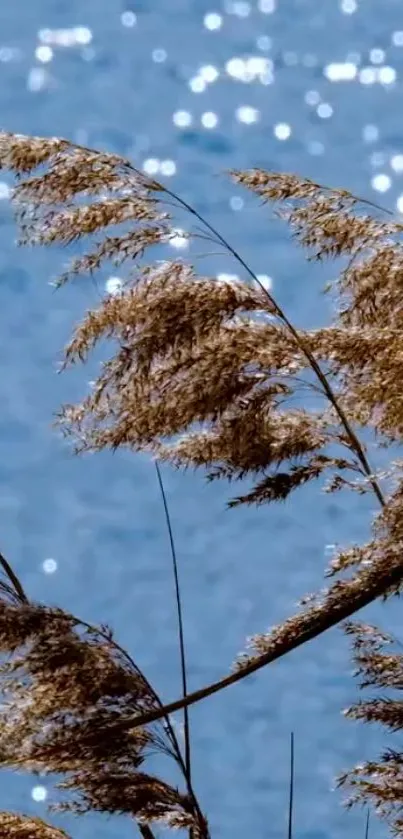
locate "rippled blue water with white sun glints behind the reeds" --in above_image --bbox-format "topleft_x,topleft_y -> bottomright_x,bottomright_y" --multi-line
0,0 -> 403,839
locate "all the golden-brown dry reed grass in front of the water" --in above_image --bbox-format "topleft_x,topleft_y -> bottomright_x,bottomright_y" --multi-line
0,133 -> 403,839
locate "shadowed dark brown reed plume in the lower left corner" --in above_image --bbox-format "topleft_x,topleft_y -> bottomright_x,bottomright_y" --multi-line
0,600 -> 202,822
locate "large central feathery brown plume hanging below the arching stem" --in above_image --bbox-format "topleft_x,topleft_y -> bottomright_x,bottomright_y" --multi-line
56,263 -> 356,500
